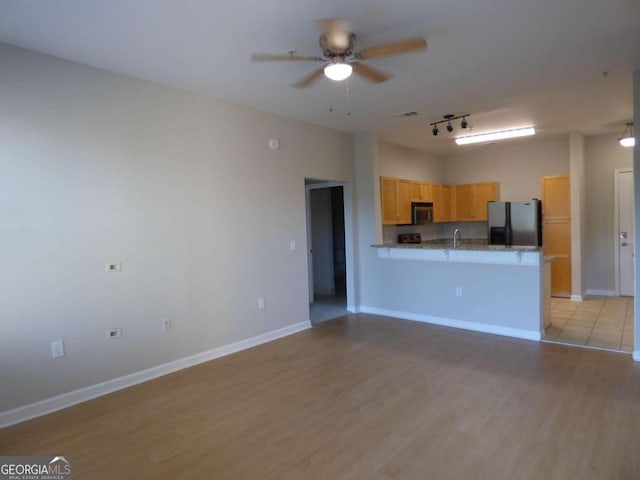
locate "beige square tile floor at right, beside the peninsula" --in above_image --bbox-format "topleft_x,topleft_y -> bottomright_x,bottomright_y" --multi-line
544,297 -> 634,352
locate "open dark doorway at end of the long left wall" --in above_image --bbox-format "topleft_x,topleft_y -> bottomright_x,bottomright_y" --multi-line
305,179 -> 350,324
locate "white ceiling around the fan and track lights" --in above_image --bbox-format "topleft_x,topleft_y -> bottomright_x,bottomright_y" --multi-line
0,0 -> 640,153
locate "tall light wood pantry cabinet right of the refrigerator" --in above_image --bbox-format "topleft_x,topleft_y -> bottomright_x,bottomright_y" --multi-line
542,175 -> 571,297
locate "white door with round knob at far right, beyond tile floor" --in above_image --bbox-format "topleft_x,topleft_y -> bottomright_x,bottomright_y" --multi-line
613,168 -> 635,297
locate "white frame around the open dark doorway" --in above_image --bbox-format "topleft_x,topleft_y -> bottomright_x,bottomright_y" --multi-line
304,178 -> 356,312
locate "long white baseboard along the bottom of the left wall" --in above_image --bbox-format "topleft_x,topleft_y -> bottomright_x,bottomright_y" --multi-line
0,321 -> 311,428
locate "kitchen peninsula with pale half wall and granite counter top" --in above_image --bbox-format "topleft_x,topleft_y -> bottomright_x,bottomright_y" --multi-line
362,242 -> 551,340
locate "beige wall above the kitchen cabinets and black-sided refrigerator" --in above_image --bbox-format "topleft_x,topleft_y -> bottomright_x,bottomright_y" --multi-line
444,138 -> 569,201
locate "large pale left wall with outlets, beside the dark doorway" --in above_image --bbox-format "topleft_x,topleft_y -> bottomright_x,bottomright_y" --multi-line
0,46 -> 354,411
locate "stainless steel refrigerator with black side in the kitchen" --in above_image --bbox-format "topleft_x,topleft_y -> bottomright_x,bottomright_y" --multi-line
487,199 -> 542,246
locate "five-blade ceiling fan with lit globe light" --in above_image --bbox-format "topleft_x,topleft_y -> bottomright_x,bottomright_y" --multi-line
251,19 -> 427,88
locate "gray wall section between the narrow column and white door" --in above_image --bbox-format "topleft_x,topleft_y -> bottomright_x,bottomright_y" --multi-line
583,133 -> 633,293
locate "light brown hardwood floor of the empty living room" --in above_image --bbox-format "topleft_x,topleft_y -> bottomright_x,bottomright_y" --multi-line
0,314 -> 640,480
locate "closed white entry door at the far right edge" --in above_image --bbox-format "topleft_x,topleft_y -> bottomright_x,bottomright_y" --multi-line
617,170 -> 635,297
